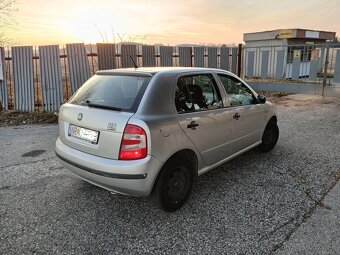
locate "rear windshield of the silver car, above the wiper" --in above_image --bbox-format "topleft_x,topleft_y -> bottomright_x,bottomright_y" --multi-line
68,75 -> 151,112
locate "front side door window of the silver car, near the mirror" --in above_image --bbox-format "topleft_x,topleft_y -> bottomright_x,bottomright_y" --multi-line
218,74 -> 257,106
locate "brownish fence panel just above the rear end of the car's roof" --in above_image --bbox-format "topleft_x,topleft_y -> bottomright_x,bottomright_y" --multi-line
97,43 -> 116,70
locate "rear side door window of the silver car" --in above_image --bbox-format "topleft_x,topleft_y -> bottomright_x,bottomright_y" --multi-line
175,74 -> 223,113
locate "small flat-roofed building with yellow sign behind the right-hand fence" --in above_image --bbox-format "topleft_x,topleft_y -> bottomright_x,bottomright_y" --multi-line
243,28 -> 336,79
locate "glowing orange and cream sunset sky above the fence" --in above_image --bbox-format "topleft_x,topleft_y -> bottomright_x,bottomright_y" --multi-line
6,0 -> 340,45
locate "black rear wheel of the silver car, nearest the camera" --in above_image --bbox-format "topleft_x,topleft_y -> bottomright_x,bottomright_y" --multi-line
151,157 -> 194,212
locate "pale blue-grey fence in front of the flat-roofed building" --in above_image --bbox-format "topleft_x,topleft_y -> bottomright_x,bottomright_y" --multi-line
242,43 -> 340,84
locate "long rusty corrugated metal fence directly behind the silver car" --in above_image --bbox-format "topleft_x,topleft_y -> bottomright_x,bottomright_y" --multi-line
0,43 -> 237,112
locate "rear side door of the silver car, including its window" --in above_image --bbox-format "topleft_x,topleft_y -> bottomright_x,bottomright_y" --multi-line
175,73 -> 232,165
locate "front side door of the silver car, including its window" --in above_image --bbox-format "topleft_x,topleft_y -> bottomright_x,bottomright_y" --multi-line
217,73 -> 265,153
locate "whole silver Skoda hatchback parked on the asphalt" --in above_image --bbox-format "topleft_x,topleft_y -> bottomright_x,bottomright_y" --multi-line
55,67 -> 279,211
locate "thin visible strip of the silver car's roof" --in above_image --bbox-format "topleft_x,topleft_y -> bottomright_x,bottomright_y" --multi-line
96,67 -> 230,76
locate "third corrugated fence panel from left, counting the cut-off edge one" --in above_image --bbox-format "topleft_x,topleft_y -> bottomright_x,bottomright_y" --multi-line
39,45 -> 64,111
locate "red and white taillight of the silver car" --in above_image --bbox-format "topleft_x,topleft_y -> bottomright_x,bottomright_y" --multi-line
119,124 -> 148,160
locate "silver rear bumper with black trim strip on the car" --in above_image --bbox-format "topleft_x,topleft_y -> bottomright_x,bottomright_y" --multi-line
55,138 -> 162,196
